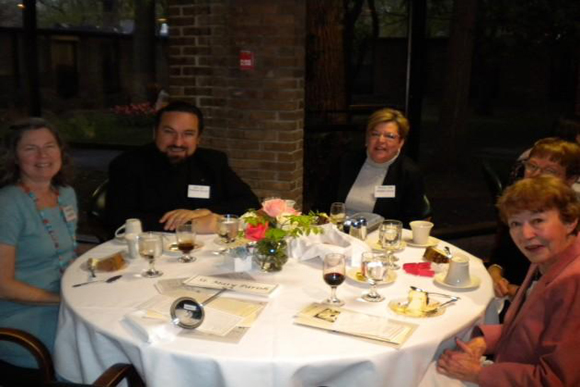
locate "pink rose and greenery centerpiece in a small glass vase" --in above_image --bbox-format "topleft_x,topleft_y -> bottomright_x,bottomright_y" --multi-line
242,199 -> 322,272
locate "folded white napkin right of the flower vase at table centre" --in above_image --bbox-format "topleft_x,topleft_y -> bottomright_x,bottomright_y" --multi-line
288,223 -> 371,266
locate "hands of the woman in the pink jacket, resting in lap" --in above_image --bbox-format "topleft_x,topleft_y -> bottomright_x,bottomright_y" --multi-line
437,337 -> 487,383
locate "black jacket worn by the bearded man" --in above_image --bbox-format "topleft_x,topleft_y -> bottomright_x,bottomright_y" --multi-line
105,144 -> 259,231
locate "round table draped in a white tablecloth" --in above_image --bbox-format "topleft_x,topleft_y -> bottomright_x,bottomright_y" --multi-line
55,230 -> 497,387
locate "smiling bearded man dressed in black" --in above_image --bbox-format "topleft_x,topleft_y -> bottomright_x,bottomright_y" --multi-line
105,102 -> 259,232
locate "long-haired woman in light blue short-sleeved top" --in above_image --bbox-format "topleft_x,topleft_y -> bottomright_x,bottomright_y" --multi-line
0,118 -> 77,368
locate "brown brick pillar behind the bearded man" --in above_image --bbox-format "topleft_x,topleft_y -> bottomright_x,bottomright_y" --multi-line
168,0 -> 306,208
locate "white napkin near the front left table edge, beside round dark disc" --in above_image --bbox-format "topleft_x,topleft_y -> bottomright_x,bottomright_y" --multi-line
124,310 -> 181,344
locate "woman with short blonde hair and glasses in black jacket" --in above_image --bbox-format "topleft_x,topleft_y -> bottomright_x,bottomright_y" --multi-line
318,109 -> 426,224
